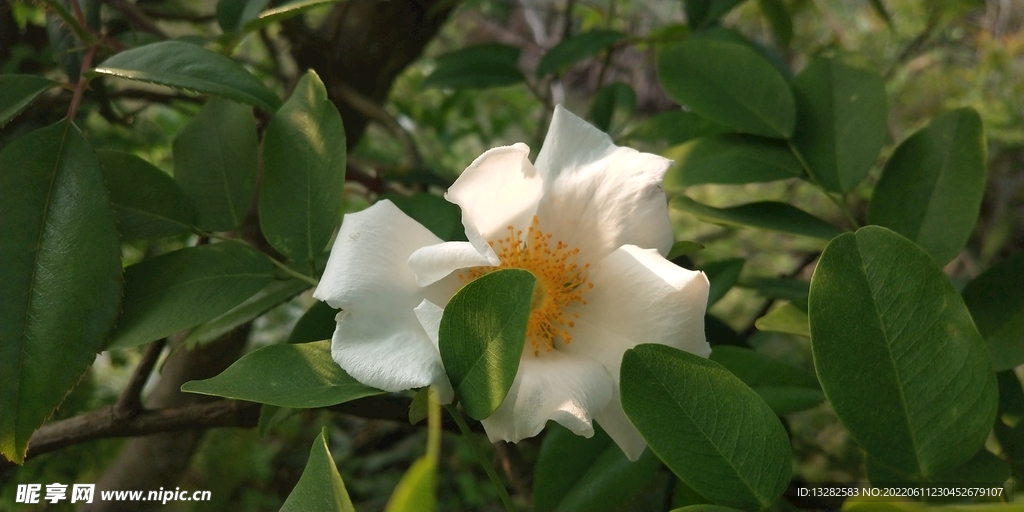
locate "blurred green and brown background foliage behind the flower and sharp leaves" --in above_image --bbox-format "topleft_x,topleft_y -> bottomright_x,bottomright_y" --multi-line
0,0 -> 1024,511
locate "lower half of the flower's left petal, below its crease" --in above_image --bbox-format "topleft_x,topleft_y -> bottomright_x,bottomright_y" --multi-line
331,308 -> 447,392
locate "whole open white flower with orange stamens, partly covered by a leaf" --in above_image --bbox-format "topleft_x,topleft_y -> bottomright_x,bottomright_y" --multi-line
313,106 -> 711,460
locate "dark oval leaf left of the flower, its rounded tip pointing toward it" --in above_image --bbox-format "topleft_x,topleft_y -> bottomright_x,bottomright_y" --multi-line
108,243 -> 273,349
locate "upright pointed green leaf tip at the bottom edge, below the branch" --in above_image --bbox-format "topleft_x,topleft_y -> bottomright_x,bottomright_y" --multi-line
281,427 -> 355,512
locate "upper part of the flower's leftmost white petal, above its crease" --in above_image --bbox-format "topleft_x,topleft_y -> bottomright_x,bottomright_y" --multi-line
313,200 -> 441,314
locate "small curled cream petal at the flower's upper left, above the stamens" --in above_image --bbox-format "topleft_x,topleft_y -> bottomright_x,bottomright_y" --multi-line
445,142 -> 544,255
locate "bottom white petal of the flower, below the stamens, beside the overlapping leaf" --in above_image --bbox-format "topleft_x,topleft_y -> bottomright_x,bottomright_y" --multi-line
481,351 -> 612,442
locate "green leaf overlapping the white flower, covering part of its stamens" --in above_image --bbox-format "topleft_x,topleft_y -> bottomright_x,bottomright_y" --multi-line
438,268 -> 537,420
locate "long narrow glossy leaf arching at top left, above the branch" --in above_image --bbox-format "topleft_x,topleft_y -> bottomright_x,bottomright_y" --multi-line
92,41 -> 281,112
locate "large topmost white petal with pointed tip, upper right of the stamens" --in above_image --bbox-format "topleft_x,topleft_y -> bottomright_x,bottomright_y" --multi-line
537,106 -> 673,264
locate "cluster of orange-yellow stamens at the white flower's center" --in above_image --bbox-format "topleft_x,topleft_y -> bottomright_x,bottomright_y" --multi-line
459,215 -> 594,356
